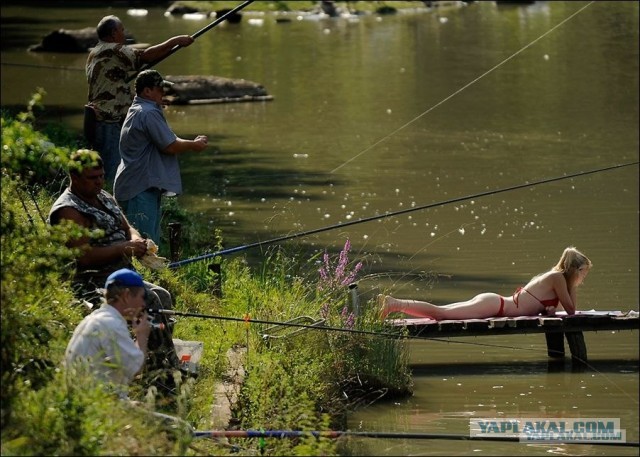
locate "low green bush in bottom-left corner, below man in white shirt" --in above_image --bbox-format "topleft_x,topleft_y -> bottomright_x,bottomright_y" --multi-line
2,370 -> 188,455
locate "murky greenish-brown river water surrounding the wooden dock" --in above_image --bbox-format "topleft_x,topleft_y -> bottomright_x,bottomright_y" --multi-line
2,1 -> 639,455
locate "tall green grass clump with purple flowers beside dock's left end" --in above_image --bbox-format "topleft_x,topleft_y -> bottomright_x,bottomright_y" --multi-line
224,241 -> 410,455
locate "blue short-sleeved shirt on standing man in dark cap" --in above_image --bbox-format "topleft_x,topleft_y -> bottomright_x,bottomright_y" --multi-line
113,96 -> 182,201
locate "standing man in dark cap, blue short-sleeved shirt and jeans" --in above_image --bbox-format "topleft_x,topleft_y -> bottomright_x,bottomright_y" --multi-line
113,70 -> 208,245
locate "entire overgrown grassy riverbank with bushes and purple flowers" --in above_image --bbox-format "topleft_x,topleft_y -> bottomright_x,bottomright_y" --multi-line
0,96 -> 411,455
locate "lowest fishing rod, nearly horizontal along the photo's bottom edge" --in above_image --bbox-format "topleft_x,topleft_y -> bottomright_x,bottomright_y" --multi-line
193,430 -> 640,447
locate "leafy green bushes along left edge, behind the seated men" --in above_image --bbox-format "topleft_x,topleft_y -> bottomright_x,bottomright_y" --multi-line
0,99 -> 198,455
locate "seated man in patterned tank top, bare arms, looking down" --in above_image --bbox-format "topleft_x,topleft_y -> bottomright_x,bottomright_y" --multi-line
49,149 -> 180,392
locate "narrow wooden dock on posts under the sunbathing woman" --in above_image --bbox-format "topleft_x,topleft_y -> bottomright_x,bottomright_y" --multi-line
386,310 -> 640,363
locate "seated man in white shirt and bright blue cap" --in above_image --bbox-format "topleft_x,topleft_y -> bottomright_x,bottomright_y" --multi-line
65,268 -> 151,397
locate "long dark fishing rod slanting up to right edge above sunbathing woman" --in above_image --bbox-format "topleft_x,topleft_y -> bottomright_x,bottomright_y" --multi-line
167,161 -> 639,268
